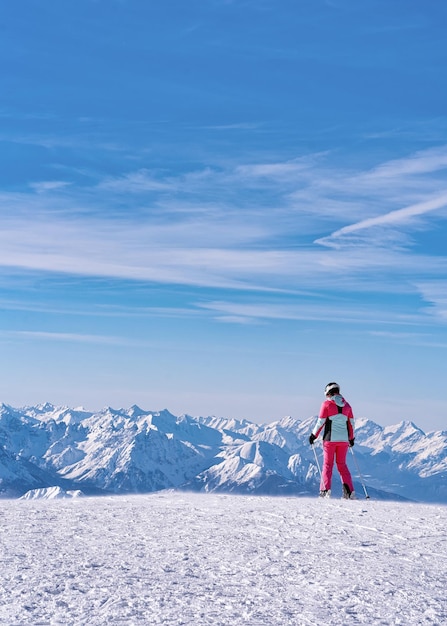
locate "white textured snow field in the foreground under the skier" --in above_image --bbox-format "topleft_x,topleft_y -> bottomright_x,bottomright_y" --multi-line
0,491 -> 447,626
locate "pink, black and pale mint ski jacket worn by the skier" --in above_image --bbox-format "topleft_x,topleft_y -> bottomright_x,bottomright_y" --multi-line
312,395 -> 354,441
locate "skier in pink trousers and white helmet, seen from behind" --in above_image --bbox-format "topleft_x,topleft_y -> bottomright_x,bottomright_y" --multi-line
309,382 -> 355,500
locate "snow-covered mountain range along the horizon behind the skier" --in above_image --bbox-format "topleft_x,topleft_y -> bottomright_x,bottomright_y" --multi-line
0,403 -> 447,502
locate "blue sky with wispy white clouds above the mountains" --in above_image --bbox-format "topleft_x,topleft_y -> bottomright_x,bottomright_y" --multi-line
0,0 -> 447,431
